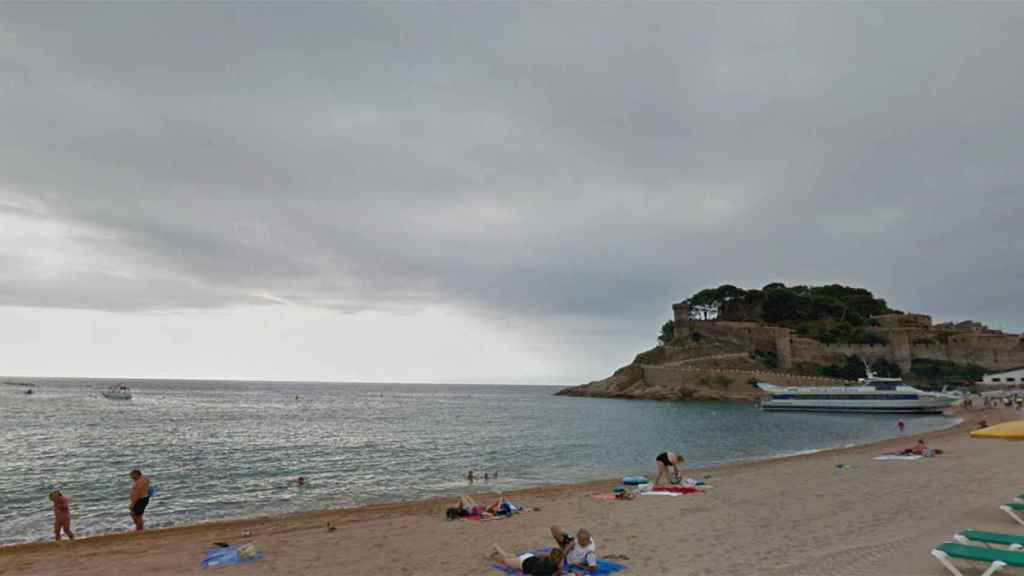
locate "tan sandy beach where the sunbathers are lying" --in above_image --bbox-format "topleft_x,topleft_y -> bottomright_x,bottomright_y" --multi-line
0,409 -> 1024,576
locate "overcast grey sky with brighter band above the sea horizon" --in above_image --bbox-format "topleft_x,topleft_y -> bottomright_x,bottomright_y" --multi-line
0,3 -> 1024,383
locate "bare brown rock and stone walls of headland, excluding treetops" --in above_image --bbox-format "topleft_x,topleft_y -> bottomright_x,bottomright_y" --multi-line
558,303 -> 1024,401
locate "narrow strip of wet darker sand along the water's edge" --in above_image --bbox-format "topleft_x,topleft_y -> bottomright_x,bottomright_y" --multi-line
0,409 -> 974,559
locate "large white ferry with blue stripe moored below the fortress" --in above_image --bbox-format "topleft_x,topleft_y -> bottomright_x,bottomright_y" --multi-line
758,369 -> 957,414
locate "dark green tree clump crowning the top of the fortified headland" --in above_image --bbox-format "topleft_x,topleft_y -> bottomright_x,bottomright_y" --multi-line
684,282 -> 900,343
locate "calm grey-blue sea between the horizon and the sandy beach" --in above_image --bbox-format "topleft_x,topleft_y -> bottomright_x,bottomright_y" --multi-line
0,380 -> 951,544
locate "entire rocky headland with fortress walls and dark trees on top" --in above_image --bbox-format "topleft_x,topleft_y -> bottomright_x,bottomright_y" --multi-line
558,283 -> 1024,401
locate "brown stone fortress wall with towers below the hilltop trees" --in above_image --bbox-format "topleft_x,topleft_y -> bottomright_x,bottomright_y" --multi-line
672,302 -> 1024,371
